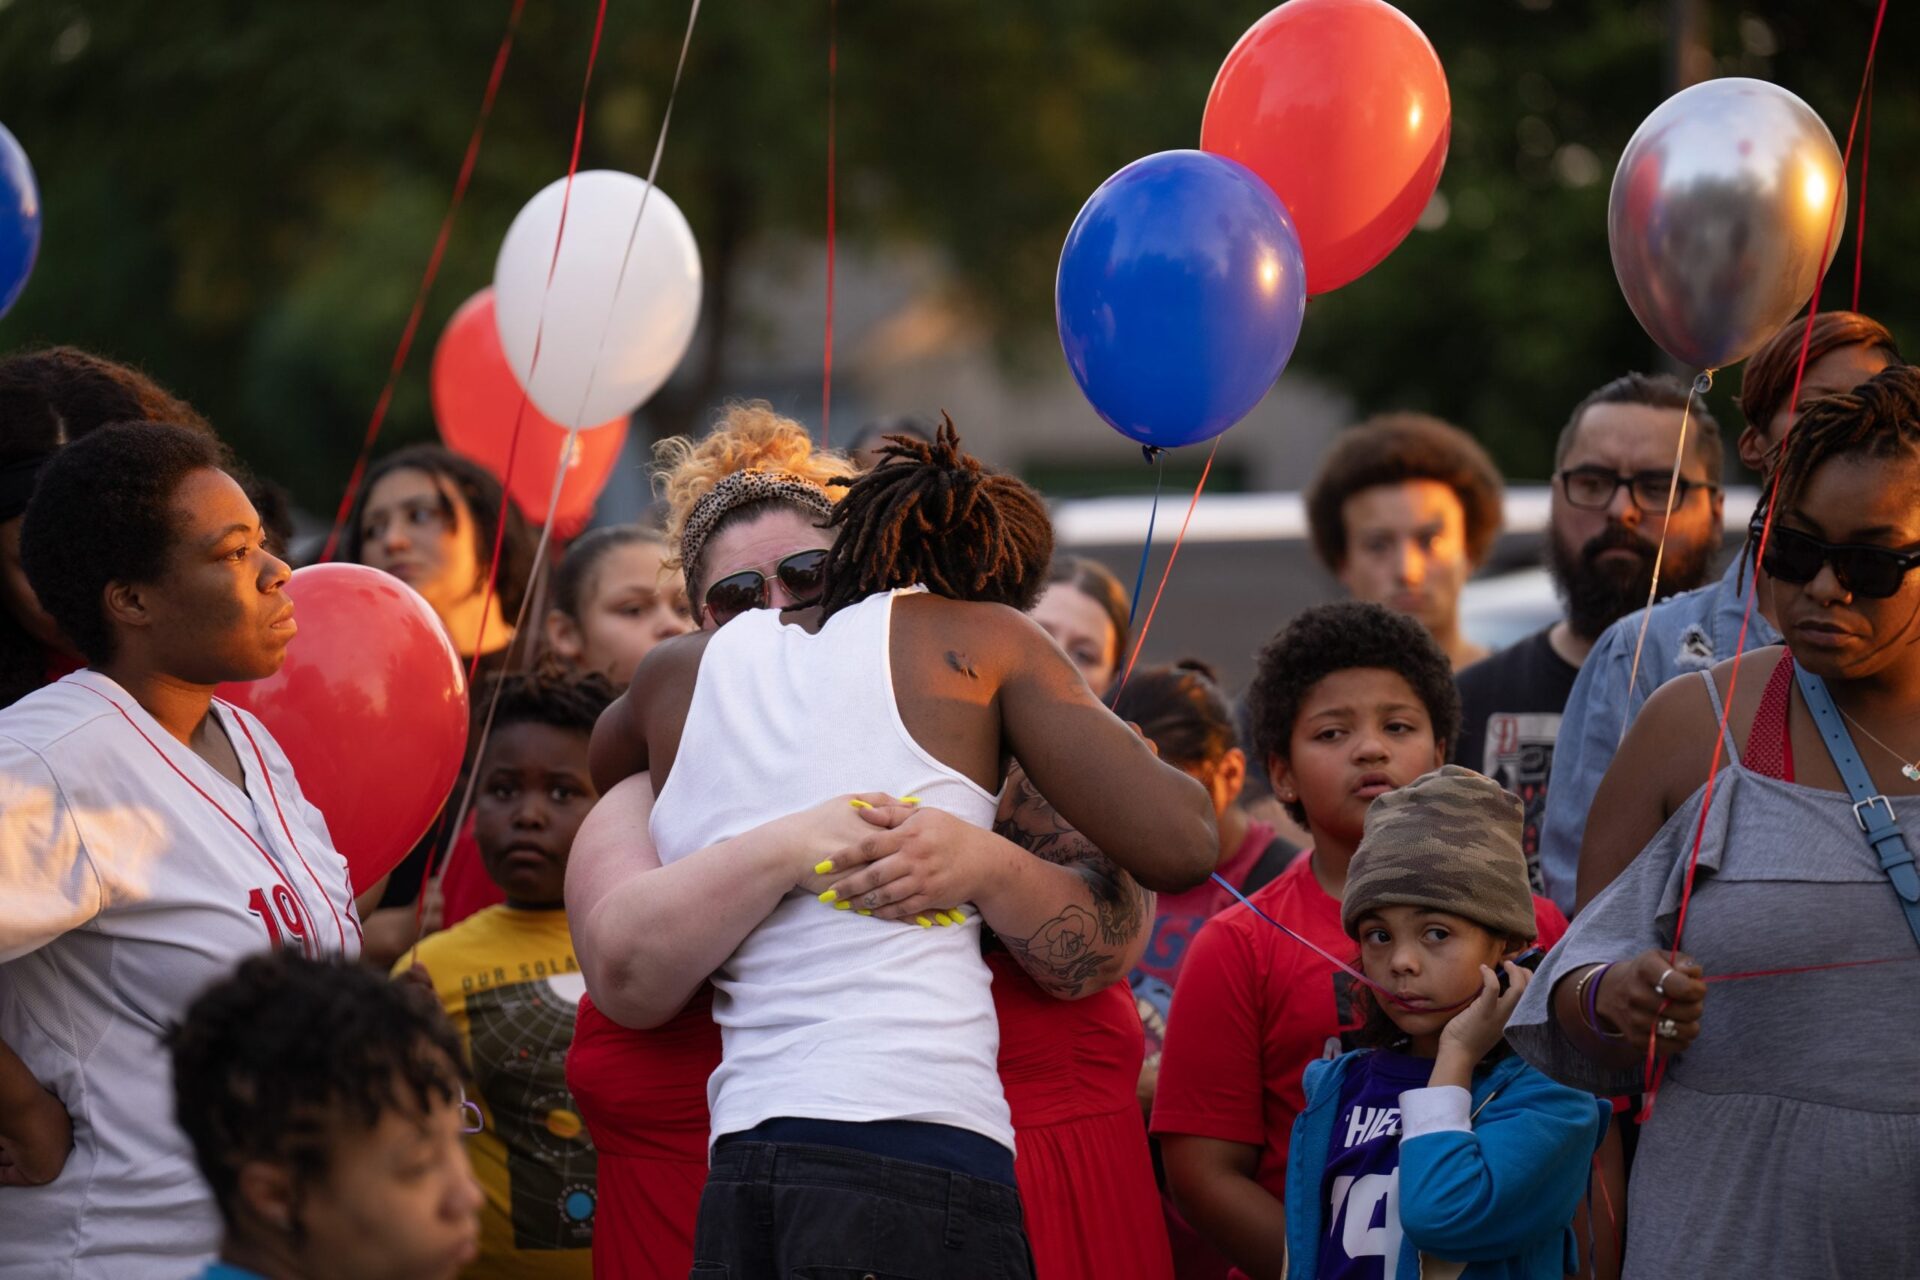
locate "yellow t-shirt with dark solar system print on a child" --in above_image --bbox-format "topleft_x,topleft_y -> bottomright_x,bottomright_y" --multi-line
396,906 -> 597,1280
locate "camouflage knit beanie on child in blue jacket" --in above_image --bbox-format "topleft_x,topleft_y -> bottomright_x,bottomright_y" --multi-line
1340,764 -> 1538,940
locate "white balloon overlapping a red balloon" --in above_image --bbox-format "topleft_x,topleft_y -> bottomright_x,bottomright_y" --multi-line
493,169 -> 701,426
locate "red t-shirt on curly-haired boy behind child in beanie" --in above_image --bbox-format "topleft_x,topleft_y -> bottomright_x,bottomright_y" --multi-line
1152,850 -> 1567,1228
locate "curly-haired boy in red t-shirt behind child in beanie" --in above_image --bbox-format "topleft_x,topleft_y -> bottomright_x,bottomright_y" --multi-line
1152,603 -> 1567,1276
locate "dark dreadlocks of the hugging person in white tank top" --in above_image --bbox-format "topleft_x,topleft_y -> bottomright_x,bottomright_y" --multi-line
820,415 -> 1054,618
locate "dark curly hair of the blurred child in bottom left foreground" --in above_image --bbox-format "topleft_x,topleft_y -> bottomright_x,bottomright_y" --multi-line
167,952 -> 463,1240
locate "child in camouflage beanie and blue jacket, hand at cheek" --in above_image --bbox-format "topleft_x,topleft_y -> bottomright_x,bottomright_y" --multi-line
1286,766 -> 1609,1280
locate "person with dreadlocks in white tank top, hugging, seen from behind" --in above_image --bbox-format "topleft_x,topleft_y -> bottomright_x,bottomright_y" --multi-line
576,424 -> 1215,1276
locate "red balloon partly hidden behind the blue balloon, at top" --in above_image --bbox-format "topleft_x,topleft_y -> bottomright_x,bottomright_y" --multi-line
1200,0 -> 1453,294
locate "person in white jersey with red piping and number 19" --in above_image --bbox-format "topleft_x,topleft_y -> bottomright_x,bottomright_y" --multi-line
0,422 -> 359,1280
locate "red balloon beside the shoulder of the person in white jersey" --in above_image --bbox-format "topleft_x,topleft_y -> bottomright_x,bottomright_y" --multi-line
219,564 -> 467,892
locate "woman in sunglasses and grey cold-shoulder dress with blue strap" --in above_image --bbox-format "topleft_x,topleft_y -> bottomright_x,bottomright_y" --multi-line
1507,365 -> 1920,1280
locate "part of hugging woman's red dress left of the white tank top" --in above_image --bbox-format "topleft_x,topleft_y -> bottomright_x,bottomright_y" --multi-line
566,986 -> 720,1280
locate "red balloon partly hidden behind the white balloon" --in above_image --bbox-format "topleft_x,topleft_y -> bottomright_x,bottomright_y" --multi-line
432,290 -> 626,537
